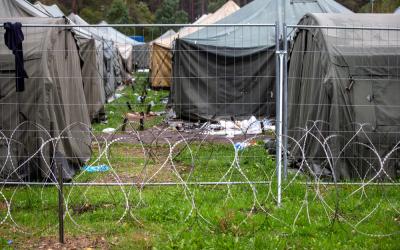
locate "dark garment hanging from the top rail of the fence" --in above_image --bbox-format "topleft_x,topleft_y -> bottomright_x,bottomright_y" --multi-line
3,22 -> 28,92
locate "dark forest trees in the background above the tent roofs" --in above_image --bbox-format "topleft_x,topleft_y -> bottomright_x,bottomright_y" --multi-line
30,0 -> 400,36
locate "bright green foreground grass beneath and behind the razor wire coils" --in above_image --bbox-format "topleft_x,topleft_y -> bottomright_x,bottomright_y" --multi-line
0,144 -> 400,249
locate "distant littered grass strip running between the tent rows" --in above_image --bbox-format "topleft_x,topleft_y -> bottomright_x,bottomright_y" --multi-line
93,73 -> 168,132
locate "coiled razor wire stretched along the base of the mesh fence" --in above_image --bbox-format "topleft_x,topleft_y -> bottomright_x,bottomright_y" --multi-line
0,121 -> 400,237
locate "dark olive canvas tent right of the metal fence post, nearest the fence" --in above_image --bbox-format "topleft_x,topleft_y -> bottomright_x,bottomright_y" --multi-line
288,14 -> 400,179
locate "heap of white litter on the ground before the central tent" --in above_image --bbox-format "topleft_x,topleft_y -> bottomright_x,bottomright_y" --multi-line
204,116 -> 275,138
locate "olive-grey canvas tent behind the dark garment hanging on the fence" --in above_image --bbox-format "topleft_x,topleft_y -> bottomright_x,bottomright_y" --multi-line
0,17 -> 91,180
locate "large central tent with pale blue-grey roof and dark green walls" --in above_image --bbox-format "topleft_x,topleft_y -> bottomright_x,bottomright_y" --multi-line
171,0 -> 351,120
